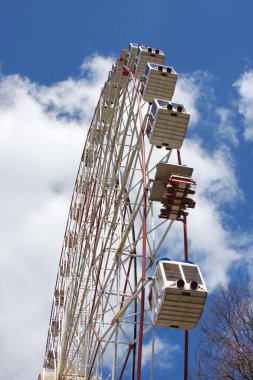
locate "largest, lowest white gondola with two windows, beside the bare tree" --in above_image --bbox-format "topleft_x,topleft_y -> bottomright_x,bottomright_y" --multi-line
149,259 -> 207,330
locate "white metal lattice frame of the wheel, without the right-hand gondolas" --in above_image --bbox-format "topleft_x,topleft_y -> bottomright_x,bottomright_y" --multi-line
41,58 -> 189,380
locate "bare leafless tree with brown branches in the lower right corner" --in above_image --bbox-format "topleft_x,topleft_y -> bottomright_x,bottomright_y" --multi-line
189,281 -> 253,380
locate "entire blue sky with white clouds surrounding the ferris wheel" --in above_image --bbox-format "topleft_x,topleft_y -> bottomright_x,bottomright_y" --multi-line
0,0 -> 253,380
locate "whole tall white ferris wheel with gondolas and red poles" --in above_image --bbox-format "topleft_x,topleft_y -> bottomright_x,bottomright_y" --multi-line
39,43 -> 207,380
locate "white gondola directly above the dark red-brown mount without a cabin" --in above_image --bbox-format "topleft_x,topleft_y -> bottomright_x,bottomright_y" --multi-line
147,99 -> 190,149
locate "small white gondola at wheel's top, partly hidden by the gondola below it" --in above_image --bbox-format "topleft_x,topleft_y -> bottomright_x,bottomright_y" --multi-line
134,46 -> 165,78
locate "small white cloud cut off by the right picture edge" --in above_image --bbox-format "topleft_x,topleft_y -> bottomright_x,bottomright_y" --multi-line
234,70 -> 253,140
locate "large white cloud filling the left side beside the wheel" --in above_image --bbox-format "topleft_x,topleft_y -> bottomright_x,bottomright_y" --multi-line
0,56 -> 111,380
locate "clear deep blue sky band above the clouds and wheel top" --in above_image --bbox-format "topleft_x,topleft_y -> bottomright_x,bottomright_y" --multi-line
0,0 -> 252,84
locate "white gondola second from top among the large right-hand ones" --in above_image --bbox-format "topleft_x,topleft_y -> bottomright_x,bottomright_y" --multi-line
141,63 -> 177,102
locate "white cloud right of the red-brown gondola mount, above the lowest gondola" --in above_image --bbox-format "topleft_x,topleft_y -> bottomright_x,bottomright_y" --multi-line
179,140 -> 243,290
